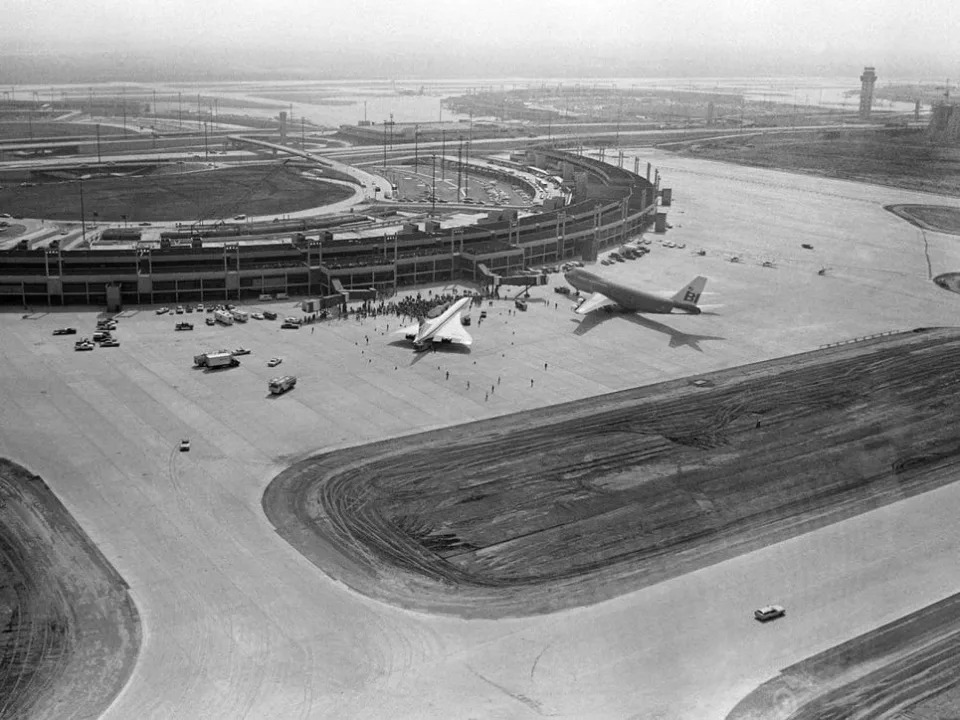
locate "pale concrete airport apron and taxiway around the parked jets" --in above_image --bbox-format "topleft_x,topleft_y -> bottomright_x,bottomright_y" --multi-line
0,153 -> 960,720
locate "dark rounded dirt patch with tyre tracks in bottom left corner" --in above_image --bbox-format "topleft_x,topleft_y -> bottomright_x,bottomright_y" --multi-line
0,459 -> 140,718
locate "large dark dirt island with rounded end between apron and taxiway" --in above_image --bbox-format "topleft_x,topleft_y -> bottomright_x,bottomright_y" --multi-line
264,330 -> 960,616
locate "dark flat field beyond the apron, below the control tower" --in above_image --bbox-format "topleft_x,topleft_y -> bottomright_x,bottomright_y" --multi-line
680,130 -> 960,196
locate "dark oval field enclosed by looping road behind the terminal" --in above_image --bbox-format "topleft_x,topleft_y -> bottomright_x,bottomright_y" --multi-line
0,164 -> 351,222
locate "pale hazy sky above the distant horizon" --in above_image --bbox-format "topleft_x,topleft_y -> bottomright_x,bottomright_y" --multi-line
0,0 -> 960,77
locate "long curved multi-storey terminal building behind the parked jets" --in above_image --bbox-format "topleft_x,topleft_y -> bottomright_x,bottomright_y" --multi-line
0,149 -> 657,308
